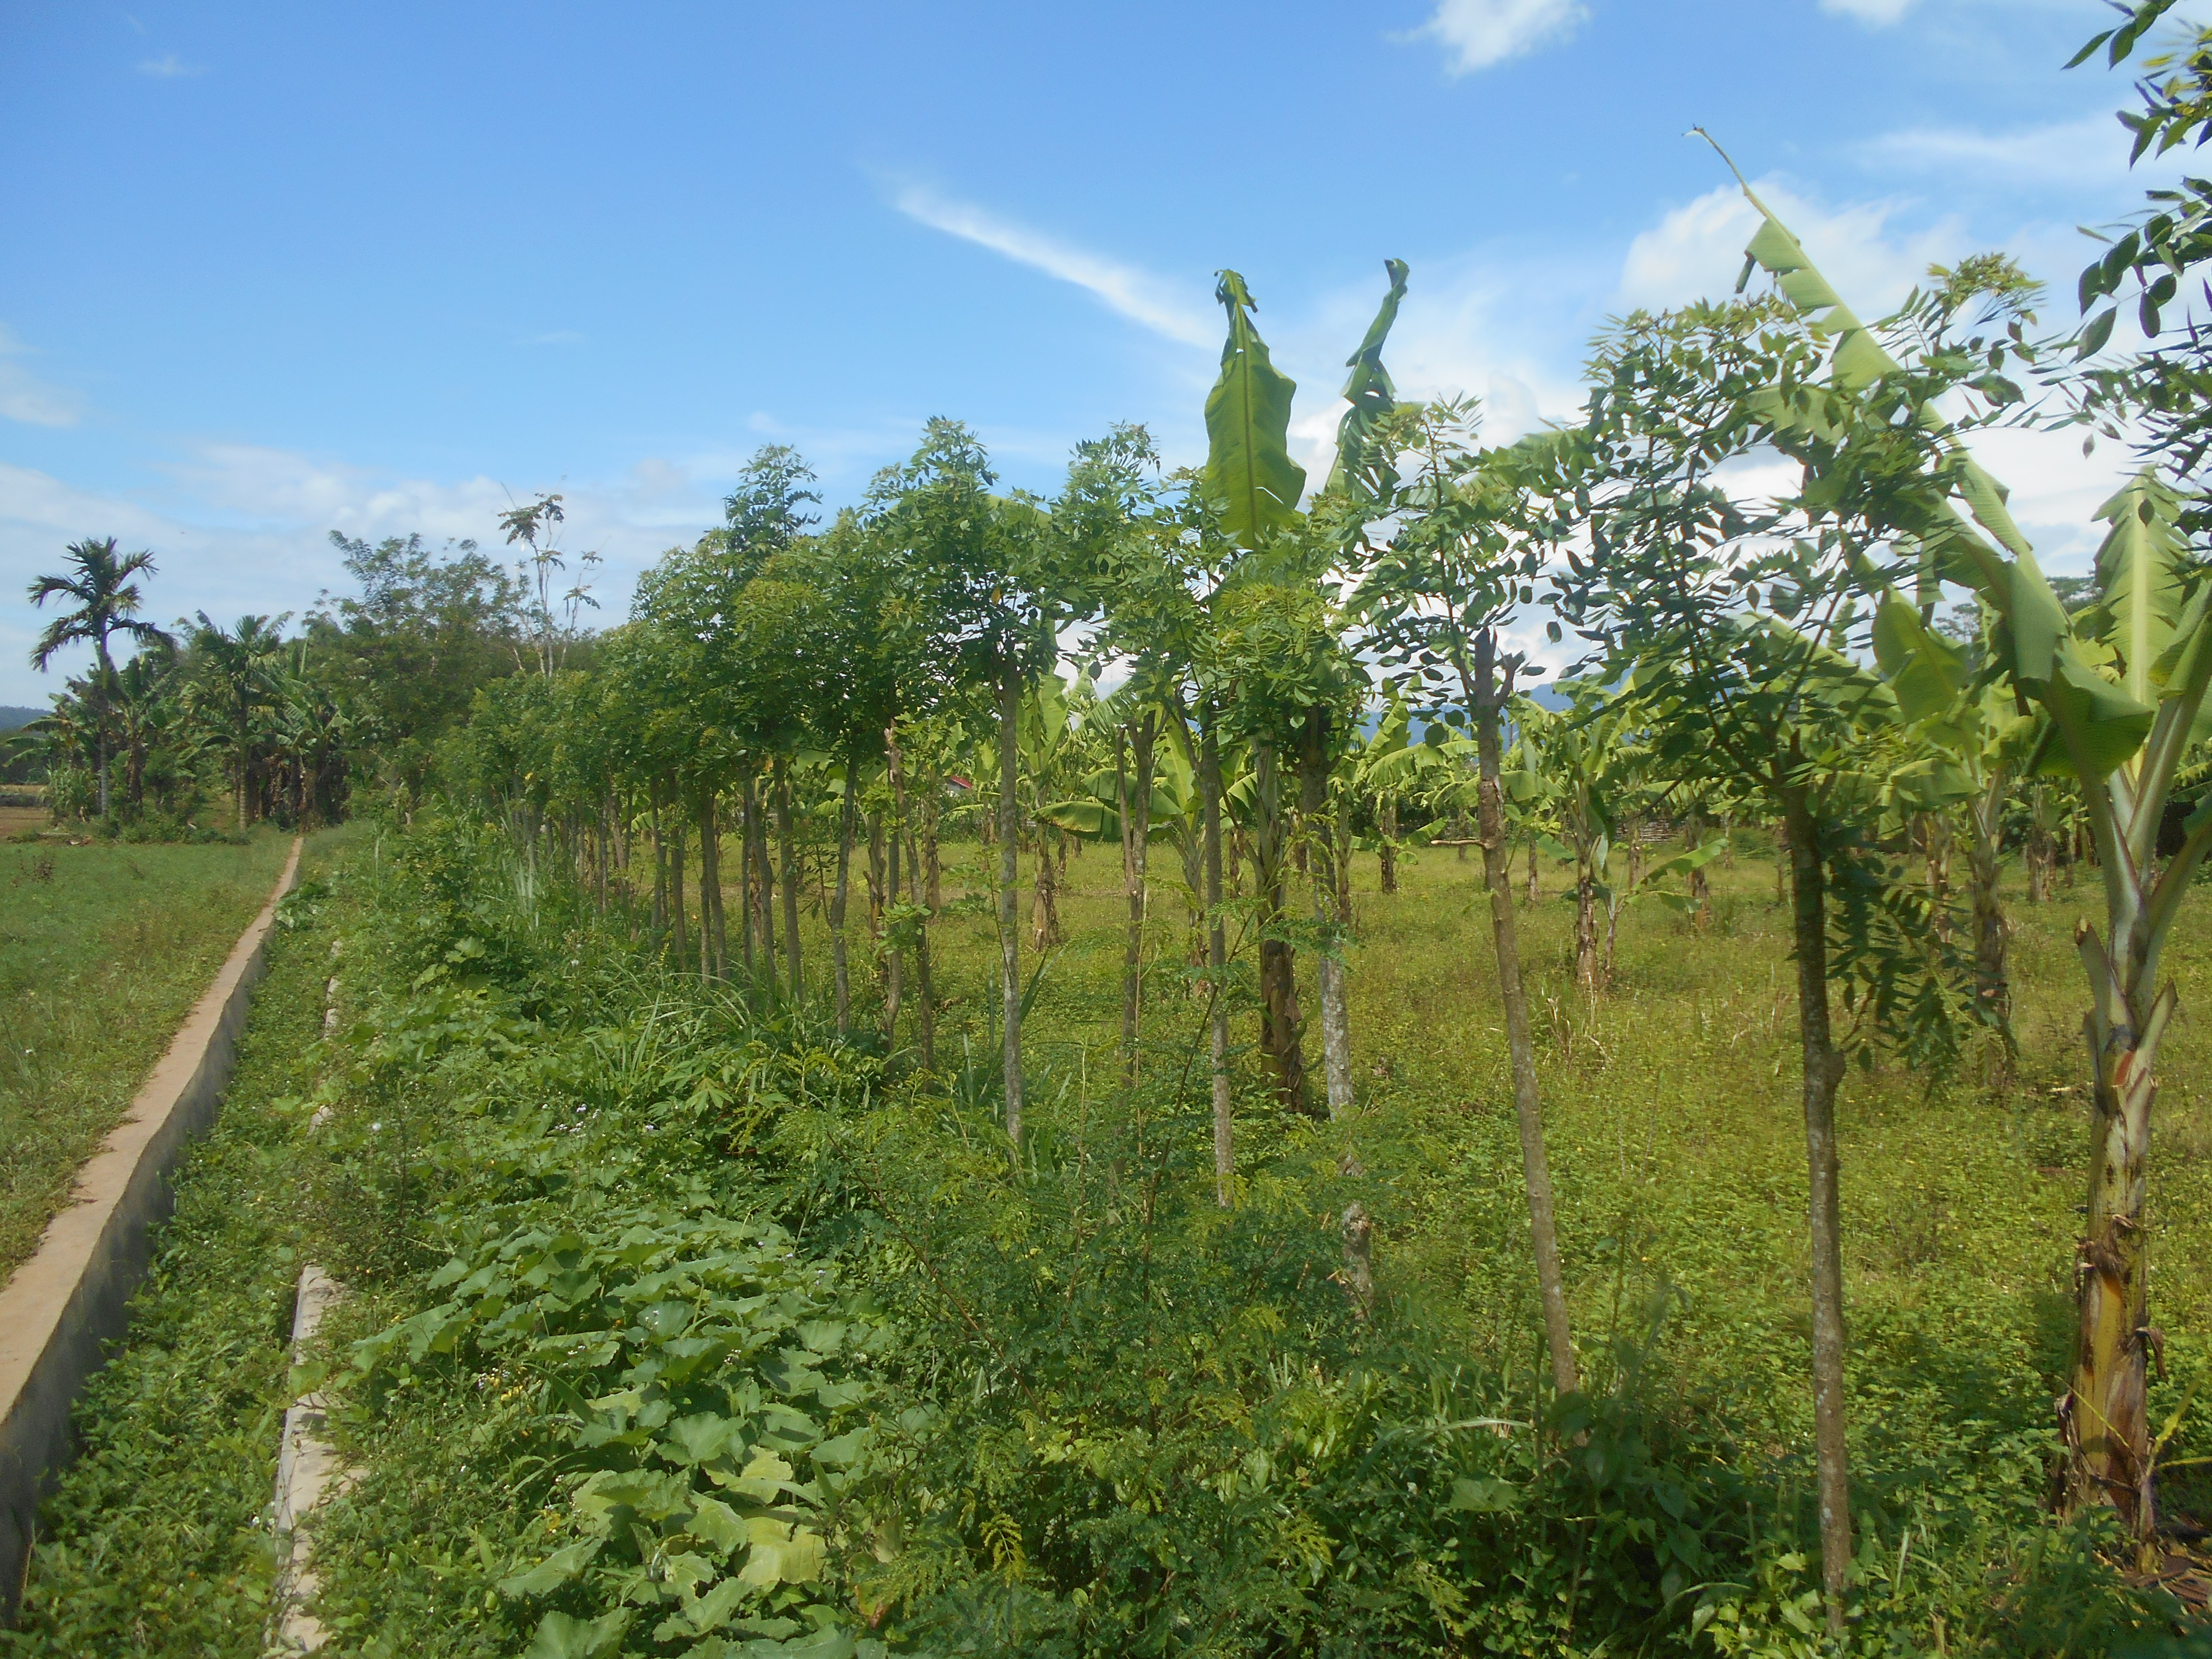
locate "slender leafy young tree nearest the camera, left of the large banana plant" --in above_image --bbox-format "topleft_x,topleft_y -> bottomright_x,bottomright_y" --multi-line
1555,280 -> 1975,1630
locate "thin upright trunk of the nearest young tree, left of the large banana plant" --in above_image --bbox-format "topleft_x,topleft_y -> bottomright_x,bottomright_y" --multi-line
1781,785 -> 1851,1635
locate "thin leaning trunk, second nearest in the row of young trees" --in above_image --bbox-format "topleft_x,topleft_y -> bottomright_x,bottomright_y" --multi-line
1467,630 -> 1582,1394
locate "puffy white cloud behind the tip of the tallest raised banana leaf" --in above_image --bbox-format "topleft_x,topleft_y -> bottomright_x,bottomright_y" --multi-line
1617,179 -> 1975,316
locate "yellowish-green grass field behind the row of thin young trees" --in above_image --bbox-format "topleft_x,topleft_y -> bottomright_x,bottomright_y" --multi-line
938,836 -> 2212,1502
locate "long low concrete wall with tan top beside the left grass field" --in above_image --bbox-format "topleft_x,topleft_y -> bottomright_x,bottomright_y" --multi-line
0,836 -> 303,1621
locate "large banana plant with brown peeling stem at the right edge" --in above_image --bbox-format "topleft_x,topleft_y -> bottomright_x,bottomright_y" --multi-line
1738,175 -> 2212,1548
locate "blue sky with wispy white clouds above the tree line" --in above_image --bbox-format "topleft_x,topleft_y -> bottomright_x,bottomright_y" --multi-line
0,0 -> 2185,703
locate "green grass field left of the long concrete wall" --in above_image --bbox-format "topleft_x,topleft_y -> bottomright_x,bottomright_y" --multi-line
0,832 -> 290,1281
